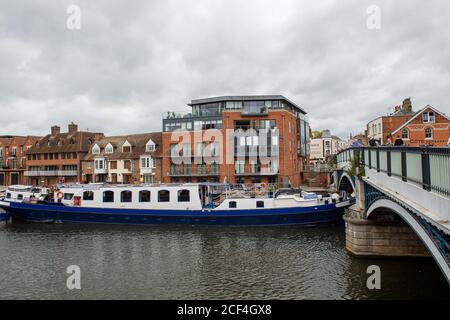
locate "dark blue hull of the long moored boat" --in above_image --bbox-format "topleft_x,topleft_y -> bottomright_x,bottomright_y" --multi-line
0,203 -> 354,226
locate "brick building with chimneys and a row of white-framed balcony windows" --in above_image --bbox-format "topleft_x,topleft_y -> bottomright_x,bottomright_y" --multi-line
25,123 -> 103,186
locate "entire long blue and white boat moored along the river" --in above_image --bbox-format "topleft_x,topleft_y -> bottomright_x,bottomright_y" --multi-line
0,183 -> 354,226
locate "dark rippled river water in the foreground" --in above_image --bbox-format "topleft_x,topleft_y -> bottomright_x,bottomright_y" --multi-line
0,222 -> 450,299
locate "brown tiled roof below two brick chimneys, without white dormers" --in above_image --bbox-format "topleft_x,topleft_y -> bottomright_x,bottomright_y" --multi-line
27,131 -> 103,154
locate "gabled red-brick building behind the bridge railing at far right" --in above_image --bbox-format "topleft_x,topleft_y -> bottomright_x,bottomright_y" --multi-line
391,105 -> 450,147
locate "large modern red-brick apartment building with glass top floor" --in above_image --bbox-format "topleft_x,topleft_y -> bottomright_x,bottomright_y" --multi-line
162,95 -> 310,186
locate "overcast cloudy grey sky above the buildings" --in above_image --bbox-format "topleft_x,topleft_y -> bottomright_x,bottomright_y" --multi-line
0,0 -> 450,137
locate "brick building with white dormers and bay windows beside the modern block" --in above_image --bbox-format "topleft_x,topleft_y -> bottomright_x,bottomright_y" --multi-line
82,132 -> 162,184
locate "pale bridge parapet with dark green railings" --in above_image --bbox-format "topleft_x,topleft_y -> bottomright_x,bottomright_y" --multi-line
337,147 -> 450,234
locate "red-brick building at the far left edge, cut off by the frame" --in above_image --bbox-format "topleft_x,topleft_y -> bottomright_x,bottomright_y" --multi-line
0,136 -> 40,186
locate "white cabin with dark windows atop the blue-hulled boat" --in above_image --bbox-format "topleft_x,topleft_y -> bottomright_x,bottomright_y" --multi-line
55,184 -> 342,210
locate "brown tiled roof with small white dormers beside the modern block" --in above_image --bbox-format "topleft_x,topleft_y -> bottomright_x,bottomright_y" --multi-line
84,132 -> 162,161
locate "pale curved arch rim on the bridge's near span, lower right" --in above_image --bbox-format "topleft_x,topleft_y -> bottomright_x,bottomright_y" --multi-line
367,198 -> 450,283
